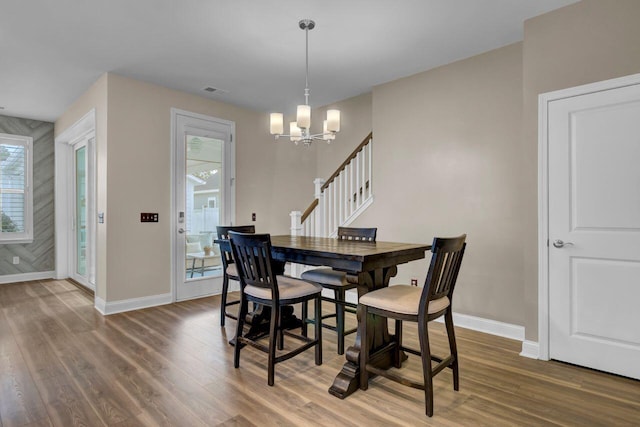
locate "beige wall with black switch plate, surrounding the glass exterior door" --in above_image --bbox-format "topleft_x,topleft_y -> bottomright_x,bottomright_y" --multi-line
56,74 -> 315,302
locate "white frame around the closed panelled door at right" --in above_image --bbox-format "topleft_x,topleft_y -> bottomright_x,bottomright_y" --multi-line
538,74 -> 640,360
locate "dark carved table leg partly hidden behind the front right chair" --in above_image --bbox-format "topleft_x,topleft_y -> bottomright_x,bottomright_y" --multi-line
329,266 -> 398,399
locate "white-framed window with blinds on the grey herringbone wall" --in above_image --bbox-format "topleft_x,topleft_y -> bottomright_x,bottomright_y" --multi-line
0,133 -> 33,244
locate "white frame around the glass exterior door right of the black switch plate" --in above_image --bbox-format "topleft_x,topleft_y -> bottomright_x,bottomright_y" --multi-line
170,108 -> 236,302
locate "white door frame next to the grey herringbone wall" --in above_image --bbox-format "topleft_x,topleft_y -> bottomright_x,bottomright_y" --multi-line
55,108 -> 98,294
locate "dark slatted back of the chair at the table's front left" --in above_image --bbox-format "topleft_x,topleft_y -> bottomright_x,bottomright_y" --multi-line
229,231 -> 278,301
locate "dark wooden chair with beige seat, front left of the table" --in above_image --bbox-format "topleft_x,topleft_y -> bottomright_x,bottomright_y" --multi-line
229,231 -> 322,386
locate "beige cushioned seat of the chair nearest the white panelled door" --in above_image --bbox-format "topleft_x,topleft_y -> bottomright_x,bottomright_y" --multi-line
359,285 -> 449,316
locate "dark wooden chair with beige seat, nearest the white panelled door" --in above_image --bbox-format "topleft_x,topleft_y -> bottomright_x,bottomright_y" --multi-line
358,234 -> 466,417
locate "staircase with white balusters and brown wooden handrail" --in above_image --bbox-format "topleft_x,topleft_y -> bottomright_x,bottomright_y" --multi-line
290,133 -> 373,237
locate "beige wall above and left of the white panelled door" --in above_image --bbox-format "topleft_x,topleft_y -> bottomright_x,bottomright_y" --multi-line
521,0 -> 640,341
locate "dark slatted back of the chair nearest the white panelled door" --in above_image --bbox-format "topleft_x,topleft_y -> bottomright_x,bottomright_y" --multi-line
420,234 -> 467,319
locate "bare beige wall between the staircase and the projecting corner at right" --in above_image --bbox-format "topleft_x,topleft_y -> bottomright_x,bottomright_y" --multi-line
357,44 -> 524,325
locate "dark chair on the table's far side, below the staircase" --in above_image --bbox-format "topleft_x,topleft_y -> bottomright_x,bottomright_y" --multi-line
300,227 -> 378,354
